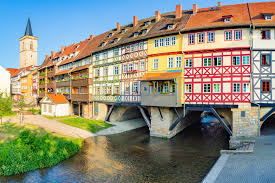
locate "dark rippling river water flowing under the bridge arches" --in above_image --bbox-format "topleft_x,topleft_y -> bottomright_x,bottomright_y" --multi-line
0,122 -> 228,183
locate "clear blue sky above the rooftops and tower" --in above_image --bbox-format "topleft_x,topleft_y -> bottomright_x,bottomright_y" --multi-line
0,0 -> 270,68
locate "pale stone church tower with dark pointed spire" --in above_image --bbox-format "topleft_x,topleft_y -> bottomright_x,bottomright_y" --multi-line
19,18 -> 38,68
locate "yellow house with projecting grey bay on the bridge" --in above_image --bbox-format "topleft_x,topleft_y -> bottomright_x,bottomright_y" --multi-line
141,34 -> 183,107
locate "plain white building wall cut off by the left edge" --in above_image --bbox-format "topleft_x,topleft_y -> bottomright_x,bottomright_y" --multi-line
0,66 -> 10,97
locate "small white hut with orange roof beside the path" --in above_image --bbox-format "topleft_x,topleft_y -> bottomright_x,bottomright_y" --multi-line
40,94 -> 70,117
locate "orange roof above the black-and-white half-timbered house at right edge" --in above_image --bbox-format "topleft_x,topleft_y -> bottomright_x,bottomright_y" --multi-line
248,1 -> 275,26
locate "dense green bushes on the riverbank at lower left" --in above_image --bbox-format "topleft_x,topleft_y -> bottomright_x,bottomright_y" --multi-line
0,130 -> 82,176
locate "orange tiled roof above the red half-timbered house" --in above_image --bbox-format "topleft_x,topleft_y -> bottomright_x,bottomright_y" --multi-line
184,4 -> 250,31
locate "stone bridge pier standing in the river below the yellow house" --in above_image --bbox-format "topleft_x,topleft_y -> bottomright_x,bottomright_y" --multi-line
149,107 -> 202,138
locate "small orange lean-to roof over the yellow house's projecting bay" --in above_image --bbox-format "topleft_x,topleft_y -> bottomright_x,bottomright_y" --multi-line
140,72 -> 182,81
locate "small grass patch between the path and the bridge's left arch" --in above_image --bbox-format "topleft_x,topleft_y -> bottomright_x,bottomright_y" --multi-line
58,117 -> 113,133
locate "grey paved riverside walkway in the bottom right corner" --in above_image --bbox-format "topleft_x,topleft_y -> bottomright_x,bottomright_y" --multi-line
202,135 -> 275,183
